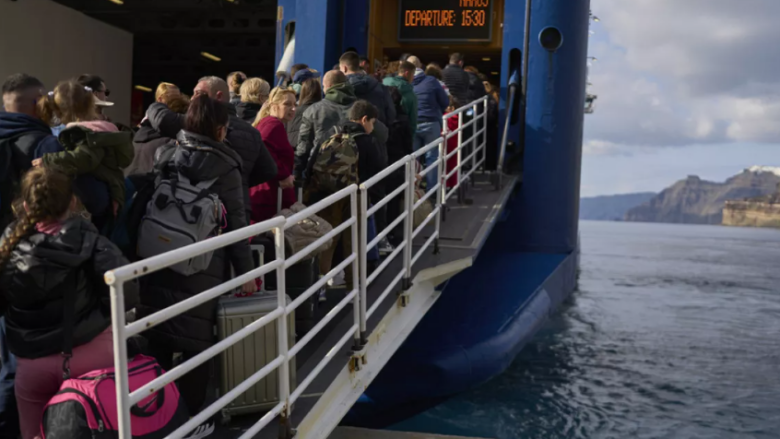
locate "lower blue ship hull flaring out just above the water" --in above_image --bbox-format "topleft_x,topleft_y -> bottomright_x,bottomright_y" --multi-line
344,205 -> 578,428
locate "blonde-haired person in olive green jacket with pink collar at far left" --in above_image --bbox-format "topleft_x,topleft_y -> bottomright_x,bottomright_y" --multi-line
33,81 -> 134,232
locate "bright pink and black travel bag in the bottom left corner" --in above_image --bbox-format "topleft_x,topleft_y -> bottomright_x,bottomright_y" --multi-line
41,355 -> 189,439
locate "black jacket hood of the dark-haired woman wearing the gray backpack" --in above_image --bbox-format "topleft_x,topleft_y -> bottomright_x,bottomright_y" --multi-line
172,130 -> 241,182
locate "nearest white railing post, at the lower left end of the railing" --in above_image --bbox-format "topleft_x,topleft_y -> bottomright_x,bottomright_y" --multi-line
106,280 -> 133,439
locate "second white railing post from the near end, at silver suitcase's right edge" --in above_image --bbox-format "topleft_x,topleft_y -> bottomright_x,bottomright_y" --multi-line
274,226 -> 290,426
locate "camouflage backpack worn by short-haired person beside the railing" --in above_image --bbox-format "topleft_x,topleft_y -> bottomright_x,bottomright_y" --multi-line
311,128 -> 366,193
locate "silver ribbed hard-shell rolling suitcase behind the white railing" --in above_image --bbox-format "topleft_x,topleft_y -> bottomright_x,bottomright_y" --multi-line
217,294 -> 297,421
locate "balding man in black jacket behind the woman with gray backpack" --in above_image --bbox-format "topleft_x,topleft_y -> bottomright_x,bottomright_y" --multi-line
146,76 -> 278,218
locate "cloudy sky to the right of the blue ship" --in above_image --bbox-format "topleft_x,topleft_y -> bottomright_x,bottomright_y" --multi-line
585,0 -> 780,154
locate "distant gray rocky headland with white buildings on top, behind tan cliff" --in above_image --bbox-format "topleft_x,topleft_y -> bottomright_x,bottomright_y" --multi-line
625,167 -> 780,224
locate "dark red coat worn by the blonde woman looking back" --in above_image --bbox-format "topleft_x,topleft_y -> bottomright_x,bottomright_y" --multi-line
249,116 -> 295,223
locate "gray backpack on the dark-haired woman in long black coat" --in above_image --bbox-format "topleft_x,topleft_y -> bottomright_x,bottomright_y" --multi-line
138,173 -> 225,276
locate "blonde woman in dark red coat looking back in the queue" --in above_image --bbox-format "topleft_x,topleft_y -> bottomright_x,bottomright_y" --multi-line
249,87 -> 296,223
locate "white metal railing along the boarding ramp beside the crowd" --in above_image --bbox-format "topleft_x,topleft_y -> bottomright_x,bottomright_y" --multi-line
105,97 -> 487,439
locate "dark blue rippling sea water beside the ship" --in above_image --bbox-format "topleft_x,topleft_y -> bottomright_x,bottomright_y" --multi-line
394,222 -> 780,439
